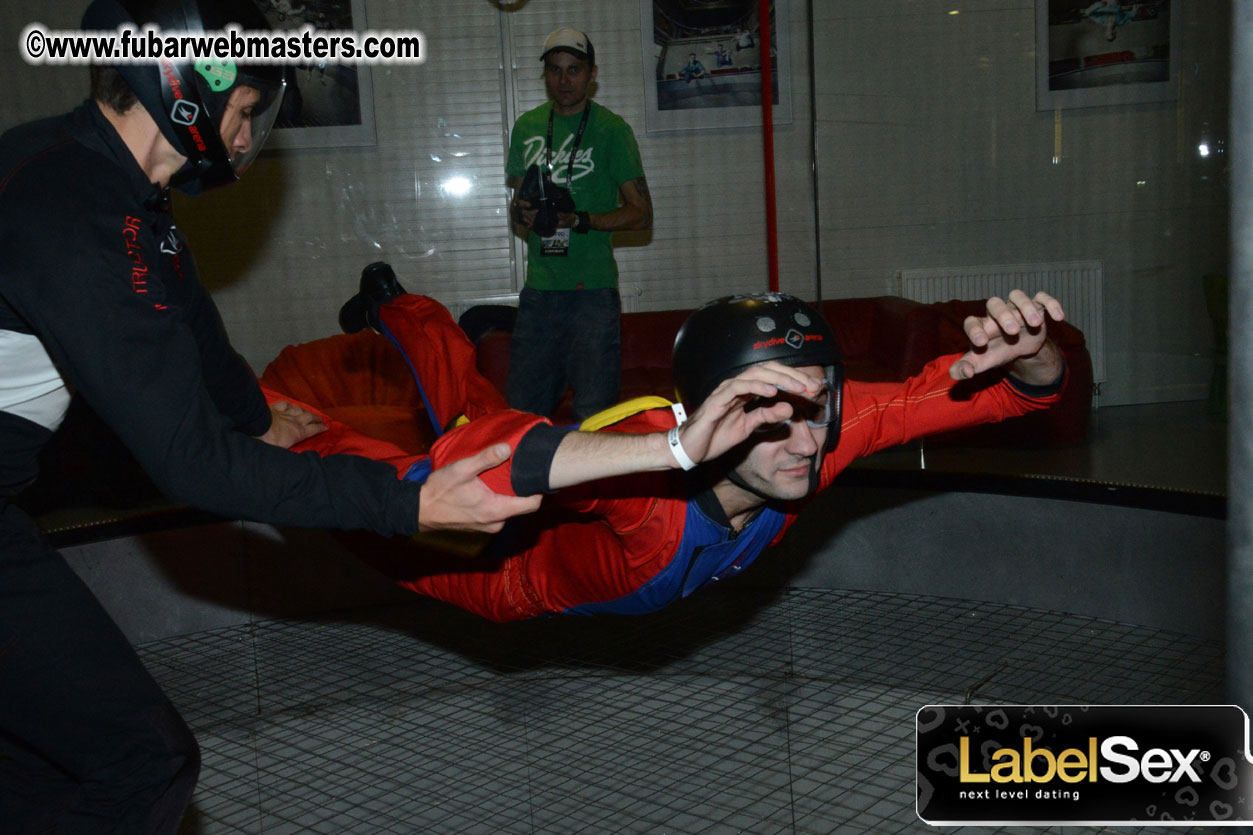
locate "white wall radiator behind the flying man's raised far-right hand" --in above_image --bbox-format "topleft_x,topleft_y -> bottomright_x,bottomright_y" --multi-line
900,261 -> 1105,390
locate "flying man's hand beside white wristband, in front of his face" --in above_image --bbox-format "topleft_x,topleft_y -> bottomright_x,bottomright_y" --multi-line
679,360 -> 826,463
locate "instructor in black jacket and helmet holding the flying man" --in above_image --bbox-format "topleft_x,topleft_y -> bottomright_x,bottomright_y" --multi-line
0,0 -> 538,832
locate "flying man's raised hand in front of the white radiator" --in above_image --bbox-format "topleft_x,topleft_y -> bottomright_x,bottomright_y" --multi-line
949,290 -> 1065,385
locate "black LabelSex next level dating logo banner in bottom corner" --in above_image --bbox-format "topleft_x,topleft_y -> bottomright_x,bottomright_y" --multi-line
916,705 -> 1253,826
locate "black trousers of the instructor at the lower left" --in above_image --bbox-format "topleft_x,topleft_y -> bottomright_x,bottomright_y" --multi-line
0,499 -> 200,835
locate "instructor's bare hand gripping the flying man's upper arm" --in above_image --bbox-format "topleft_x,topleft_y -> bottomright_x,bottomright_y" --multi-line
417,444 -> 541,533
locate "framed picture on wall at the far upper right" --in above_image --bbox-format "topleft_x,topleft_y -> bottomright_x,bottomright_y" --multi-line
1035,0 -> 1182,110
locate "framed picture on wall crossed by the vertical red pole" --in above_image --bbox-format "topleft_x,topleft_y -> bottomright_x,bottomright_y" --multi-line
639,0 -> 792,133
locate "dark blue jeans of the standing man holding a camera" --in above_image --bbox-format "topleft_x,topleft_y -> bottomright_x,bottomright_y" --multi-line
505,287 -> 621,421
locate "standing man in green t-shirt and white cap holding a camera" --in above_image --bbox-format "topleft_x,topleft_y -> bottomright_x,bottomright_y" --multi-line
505,29 -> 653,421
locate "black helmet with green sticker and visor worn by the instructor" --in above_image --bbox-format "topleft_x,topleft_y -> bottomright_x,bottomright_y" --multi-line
83,0 -> 287,193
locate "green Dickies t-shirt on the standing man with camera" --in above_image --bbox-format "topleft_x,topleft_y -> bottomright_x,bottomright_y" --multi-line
505,102 -> 644,290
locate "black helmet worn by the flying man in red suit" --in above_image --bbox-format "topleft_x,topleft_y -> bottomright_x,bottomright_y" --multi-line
673,293 -> 845,418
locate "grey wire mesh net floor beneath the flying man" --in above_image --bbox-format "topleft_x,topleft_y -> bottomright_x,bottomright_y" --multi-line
146,588 -> 1222,835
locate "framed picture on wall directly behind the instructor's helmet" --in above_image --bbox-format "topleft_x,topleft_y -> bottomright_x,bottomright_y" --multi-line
263,0 -> 375,148
